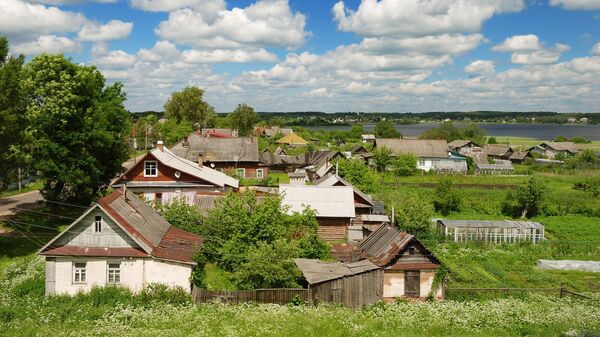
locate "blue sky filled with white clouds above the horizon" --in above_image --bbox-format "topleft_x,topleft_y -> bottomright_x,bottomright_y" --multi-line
0,0 -> 600,112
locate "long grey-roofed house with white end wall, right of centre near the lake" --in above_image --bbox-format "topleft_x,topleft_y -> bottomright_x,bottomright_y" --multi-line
375,138 -> 467,173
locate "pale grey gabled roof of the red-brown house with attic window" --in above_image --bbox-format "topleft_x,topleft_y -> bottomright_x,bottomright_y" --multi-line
112,147 -> 239,188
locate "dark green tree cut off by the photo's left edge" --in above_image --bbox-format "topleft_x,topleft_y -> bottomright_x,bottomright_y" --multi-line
0,37 -> 27,189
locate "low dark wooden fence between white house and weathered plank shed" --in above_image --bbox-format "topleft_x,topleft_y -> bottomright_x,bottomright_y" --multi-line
192,287 -> 312,304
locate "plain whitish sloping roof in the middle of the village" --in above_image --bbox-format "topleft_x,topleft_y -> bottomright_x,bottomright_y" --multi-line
279,185 -> 355,218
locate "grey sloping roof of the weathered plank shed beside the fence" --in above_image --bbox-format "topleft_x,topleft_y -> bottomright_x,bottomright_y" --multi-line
294,259 -> 379,284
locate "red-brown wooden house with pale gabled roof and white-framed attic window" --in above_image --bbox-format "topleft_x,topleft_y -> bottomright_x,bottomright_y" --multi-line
111,141 -> 239,205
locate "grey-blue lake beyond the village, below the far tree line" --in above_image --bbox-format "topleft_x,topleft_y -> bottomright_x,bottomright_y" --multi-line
306,123 -> 600,141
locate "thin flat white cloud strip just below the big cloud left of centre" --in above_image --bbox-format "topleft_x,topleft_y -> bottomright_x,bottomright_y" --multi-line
182,49 -> 277,63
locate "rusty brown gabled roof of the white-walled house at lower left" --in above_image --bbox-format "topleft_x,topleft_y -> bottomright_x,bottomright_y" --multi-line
39,190 -> 202,264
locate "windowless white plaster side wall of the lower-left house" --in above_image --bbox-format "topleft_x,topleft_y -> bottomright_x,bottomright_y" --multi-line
146,260 -> 192,290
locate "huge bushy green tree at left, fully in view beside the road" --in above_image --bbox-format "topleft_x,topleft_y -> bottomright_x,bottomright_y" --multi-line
21,54 -> 130,203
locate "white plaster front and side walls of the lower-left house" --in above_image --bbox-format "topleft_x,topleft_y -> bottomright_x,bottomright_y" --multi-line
46,257 -> 192,295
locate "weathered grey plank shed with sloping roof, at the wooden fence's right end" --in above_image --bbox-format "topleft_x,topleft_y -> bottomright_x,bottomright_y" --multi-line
294,259 -> 383,308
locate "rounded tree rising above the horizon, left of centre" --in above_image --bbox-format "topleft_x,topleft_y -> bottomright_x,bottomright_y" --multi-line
164,87 -> 215,128
